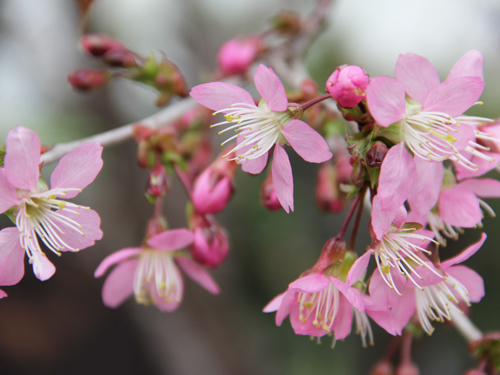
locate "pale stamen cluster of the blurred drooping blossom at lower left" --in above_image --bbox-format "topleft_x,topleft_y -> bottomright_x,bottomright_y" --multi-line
134,249 -> 182,305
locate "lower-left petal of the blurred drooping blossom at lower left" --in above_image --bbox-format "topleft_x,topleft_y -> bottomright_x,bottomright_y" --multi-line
102,259 -> 139,309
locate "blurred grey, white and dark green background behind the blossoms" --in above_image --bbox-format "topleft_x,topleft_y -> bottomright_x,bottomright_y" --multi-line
0,0 -> 500,375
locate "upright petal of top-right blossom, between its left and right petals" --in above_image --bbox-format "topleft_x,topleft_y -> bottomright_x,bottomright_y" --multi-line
395,53 -> 441,103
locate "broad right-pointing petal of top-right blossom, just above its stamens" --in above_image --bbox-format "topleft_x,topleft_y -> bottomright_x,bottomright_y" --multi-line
423,77 -> 484,117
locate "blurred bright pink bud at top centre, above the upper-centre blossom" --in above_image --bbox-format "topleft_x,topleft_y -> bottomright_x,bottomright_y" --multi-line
217,35 -> 262,75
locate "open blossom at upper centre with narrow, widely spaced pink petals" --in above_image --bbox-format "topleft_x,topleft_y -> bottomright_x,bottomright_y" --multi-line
191,65 -> 332,212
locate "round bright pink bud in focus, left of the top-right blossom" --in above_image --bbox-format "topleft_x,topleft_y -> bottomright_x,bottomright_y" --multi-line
326,65 -> 370,108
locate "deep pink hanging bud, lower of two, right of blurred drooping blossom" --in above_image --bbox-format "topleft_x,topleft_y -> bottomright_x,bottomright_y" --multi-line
189,215 -> 229,269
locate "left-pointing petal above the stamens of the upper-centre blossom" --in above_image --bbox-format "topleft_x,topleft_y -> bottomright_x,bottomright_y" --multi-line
189,82 -> 255,111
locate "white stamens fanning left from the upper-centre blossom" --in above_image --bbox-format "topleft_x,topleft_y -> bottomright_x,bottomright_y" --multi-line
211,101 -> 291,162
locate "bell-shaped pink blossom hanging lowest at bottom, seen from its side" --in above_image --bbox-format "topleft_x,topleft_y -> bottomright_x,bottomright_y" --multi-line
263,250 -> 373,344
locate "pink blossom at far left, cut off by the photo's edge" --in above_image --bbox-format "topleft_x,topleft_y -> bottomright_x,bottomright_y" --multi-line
0,127 -> 102,285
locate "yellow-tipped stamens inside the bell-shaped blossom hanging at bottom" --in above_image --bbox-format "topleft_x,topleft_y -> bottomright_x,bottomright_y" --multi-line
297,282 -> 339,332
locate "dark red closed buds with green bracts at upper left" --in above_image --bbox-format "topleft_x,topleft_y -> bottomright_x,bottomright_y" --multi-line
68,34 -> 188,106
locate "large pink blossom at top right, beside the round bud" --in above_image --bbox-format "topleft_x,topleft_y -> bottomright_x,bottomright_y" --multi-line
366,50 -> 491,170
